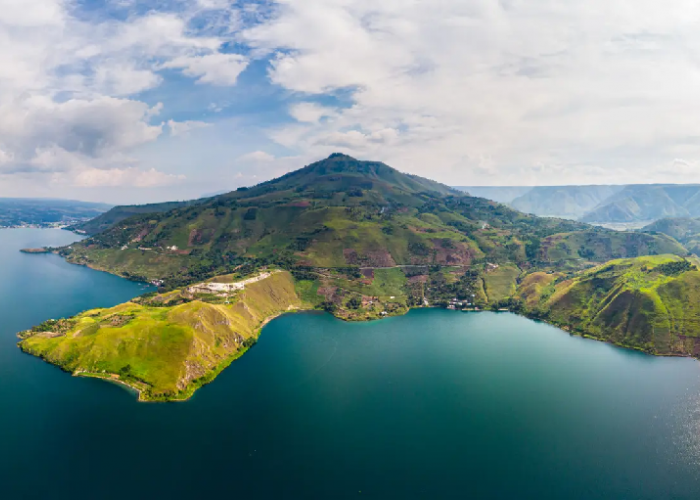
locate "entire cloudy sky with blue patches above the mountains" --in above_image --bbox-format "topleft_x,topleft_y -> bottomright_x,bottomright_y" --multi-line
0,0 -> 700,203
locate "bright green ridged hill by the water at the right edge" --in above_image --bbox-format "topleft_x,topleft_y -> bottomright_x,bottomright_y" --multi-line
518,255 -> 700,356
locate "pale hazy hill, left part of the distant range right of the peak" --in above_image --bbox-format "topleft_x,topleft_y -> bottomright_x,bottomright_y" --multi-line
510,186 -> 624,219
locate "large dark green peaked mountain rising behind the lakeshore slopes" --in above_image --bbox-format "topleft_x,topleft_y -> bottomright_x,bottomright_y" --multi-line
61,154 -> 686,286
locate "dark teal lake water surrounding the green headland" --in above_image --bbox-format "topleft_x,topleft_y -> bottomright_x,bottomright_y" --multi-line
0,229 -> 700,500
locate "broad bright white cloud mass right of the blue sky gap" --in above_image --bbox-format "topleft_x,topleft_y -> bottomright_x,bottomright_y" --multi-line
242,0 -> 700,184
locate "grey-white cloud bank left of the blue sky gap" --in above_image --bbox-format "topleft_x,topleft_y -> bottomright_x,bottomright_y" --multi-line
0,0 -> 247,191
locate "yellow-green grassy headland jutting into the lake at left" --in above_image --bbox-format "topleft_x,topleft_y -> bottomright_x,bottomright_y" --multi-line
20,272 -> 303,401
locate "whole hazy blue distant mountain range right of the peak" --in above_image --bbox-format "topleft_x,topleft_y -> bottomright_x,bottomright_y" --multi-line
457,184 -> 700,223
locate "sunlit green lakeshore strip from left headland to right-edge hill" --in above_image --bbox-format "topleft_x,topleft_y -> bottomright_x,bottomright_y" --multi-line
19,250 -> 700,401
